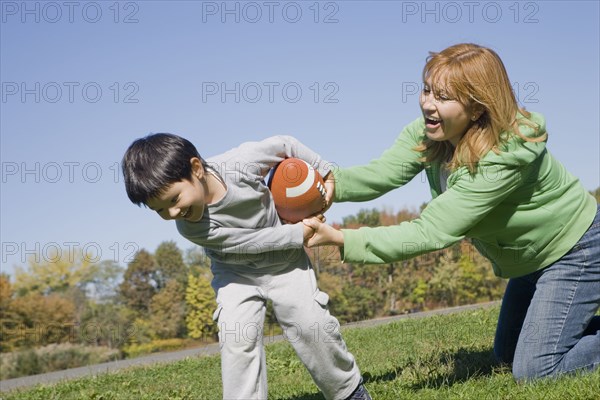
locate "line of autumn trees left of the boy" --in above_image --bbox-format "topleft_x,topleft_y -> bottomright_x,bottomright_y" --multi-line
0,242 -> 216,379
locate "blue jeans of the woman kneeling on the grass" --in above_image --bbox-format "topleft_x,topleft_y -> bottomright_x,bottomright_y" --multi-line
494,207 -> 600,380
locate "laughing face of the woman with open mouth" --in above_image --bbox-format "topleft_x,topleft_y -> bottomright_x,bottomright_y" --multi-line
419,81 -> 476,147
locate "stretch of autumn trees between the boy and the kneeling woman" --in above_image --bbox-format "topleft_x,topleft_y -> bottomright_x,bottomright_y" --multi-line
311,209 -> 505,322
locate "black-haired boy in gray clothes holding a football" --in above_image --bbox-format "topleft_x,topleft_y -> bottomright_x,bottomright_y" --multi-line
122,133 -> 371,400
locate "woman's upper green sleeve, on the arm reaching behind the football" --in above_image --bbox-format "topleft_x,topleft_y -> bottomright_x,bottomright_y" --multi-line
333,118 -> 424,202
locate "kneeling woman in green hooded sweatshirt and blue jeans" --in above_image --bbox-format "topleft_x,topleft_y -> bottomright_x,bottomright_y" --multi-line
304,44 -> 600,379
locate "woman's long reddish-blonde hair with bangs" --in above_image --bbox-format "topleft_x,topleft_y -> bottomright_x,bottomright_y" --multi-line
415,43 -> 546,173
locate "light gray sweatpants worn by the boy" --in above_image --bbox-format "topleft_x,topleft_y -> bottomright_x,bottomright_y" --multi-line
212,266 -> 361,400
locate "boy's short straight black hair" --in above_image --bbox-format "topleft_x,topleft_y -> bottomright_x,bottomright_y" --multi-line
121,133 -> 206,206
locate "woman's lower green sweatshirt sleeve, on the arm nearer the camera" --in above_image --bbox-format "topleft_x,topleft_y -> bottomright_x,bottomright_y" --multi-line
342,164 -> 525,264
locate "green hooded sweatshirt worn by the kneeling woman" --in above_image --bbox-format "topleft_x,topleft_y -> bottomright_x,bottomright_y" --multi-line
333,113 -> 597,278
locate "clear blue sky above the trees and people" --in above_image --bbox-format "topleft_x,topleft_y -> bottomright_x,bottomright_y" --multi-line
0,1 -> 600,273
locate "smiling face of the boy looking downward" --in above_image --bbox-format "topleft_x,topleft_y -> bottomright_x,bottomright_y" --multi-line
147,159 -> 207,222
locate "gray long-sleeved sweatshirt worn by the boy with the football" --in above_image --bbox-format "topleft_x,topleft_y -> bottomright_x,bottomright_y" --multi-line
177,136 -> 331,274
